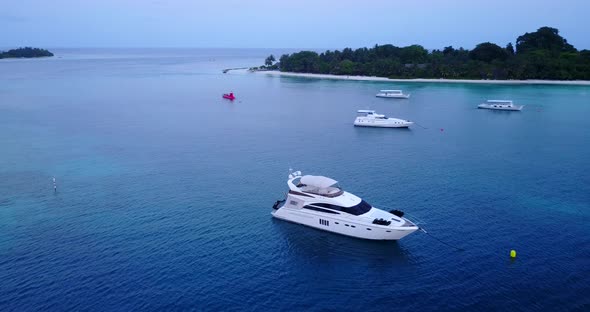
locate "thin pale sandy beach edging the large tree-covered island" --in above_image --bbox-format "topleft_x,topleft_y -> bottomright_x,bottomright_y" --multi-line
255,71 -> 590,86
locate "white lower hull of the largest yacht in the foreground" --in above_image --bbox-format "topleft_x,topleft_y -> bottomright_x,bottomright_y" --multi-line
271,206 -> 418,240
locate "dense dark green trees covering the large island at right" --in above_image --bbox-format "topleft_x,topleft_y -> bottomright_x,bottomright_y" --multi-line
272,27 -> 590,80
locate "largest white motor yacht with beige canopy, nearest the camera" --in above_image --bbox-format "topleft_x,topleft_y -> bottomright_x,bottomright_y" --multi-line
272,171 -> 419,240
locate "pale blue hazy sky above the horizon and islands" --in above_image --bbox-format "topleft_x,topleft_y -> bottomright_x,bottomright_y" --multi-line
0,0 -> 590,49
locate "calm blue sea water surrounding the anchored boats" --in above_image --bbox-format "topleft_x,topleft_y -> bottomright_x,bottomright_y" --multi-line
0,50 -> 590,311
